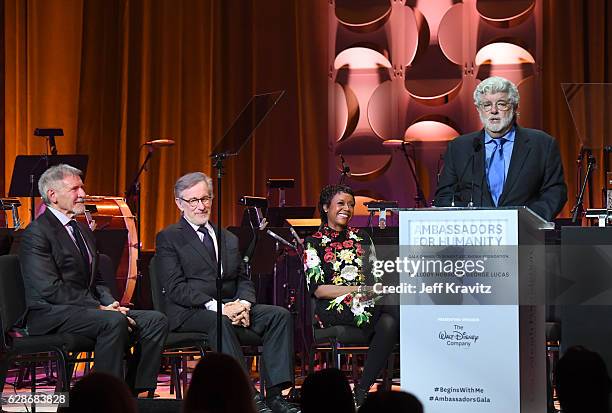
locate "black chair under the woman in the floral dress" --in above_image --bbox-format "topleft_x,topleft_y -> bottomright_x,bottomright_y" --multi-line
309,297 -> 399,390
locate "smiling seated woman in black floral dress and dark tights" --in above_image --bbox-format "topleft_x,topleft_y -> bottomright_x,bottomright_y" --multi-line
304,185 -> 399,405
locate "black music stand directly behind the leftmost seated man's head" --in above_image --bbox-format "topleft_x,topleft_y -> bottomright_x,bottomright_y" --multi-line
9,154 -> 88,222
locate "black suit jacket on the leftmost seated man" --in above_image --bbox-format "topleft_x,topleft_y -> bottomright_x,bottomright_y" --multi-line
19,208 -> 115,334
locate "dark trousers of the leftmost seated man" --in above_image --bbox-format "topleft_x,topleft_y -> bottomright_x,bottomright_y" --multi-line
54,308 -> 168,391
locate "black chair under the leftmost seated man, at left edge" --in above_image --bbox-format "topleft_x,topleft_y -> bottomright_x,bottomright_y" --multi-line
0,255 -> 95,392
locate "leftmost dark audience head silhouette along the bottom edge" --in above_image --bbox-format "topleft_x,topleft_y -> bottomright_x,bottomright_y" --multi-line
58,372 -> 138,413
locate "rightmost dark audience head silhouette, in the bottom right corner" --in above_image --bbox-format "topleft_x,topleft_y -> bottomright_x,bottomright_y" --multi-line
556,346 -> 611,413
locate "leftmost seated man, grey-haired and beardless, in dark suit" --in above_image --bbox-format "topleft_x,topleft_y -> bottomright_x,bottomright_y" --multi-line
19,165 -> 168,394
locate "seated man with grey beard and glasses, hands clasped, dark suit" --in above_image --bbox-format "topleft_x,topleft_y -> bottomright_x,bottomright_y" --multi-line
155,172 -> 299,413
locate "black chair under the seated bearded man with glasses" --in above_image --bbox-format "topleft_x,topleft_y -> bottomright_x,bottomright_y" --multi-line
149,257 -> 265,399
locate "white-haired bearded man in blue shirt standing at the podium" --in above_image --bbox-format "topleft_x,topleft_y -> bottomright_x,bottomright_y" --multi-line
435,77 -> 567,221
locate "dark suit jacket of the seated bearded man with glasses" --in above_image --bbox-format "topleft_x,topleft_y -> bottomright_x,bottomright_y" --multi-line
155,218 -> 256,330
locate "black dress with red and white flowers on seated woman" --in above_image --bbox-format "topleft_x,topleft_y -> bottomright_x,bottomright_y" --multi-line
304,225 -> 378,327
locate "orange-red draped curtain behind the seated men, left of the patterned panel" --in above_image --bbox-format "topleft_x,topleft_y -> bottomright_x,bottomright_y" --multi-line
2,0 -> 328,248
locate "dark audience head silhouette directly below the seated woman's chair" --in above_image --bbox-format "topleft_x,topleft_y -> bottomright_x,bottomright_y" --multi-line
301,369 -> 355,413
